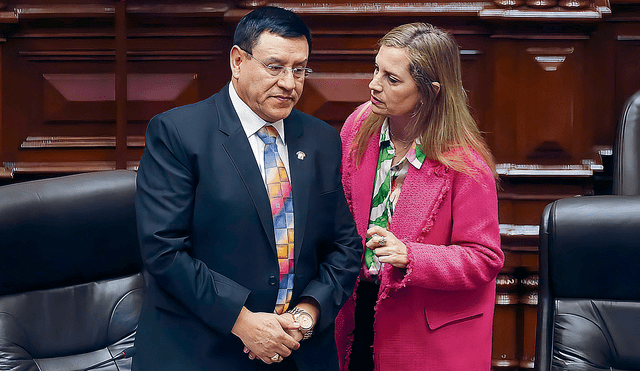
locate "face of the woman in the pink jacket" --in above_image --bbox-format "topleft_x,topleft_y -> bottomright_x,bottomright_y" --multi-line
369,46 -> 420,122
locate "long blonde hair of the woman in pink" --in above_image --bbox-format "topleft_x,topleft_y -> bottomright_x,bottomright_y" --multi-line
351,23 -> 498,179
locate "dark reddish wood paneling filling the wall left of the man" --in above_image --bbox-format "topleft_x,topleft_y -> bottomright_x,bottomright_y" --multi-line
0,1 -> 230,174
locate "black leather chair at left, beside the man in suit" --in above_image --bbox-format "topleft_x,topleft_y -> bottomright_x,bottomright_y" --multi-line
0,170 -> 144,371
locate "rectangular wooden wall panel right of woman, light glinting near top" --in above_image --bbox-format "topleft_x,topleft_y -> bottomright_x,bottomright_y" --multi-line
493,40 -> 590,164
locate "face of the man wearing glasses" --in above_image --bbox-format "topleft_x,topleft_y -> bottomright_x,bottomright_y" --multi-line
231,32 -> 309,122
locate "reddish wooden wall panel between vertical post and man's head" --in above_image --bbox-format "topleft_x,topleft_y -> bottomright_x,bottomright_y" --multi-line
127,32 -> 231,131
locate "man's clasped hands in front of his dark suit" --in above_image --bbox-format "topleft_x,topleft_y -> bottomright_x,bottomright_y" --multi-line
231,307 -> 302,364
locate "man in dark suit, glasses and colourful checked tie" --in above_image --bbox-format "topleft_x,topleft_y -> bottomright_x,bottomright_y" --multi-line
133,7 -> 362,371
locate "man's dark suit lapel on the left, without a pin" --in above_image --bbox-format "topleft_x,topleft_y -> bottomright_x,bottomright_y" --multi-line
216,85 -> 276,253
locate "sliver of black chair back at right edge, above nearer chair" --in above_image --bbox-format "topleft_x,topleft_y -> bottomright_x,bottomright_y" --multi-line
613,91 -> 640,196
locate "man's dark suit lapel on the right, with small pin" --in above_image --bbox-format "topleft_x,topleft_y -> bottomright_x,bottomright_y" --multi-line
284,115 -> 313,263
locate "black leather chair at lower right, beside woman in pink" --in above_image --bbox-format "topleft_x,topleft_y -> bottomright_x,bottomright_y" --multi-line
535,195 -> 640,371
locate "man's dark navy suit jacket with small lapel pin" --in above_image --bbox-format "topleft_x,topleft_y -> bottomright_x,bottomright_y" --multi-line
133,85 -> 362,371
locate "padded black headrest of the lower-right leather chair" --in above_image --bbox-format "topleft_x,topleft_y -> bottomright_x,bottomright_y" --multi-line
541,196 -> 640,300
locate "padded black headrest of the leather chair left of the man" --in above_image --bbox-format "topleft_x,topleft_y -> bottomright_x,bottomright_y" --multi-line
0,170 -> 142,295
